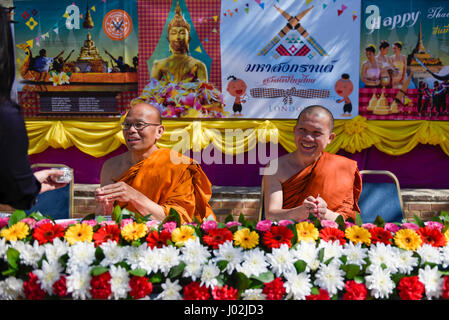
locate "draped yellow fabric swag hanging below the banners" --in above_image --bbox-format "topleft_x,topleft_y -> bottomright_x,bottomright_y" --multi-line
25,116 -> 449,157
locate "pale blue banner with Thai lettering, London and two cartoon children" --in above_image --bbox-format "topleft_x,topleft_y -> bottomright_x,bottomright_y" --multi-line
220,0 -> 361,119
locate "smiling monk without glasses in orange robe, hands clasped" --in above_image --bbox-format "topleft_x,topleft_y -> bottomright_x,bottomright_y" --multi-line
264,105 -> 362,221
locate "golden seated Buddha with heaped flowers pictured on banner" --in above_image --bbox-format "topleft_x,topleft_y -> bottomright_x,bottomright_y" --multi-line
131,2 -> 226,118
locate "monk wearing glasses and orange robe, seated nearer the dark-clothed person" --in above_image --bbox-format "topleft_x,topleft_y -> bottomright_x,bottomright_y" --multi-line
95,103 -> 215,223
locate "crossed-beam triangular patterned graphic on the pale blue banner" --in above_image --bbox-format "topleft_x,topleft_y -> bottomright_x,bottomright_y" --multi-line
257,5 -> 327,59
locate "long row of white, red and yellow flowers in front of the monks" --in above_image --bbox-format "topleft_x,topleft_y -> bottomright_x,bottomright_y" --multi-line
0,207 -> 449,300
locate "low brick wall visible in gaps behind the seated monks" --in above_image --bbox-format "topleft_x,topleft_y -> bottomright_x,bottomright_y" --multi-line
0,184 -> 449,221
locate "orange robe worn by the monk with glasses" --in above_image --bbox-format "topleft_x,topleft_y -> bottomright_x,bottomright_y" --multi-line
114,149 -> 215,223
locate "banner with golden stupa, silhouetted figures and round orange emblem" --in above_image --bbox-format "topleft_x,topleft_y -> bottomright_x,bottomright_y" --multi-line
14,0 -> 138,117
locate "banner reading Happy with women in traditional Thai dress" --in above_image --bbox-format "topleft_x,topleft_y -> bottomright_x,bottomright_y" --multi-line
359,0 -> 449,120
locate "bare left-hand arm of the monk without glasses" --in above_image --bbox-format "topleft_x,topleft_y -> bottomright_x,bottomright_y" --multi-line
263,170 -> 313,220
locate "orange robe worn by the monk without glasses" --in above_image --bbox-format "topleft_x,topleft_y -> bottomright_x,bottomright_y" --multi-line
282,152 -> 362,221
